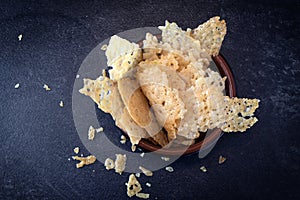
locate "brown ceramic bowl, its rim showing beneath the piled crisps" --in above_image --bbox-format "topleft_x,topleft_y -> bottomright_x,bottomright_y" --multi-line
139,55 -> 236,156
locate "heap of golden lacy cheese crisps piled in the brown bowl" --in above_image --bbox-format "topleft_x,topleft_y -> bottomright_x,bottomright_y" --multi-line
80,17 -> 259,150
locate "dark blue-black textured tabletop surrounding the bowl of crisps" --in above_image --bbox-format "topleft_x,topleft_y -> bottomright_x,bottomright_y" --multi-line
0,0 -> 300,199
